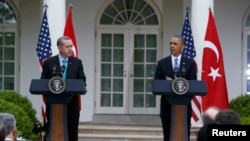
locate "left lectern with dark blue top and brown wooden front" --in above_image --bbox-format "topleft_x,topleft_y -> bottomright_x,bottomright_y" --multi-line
30,79 -> 87,141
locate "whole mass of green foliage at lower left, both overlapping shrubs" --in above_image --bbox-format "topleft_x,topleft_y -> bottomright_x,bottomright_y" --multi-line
0,91 -> 36,140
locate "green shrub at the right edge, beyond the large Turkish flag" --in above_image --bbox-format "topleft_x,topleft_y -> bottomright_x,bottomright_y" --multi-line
230,94 -> 250,124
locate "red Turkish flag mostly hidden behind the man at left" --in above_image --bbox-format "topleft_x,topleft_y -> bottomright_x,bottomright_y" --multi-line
63,7 -> 81,110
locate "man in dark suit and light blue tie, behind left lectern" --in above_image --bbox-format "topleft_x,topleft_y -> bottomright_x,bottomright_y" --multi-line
41,36 -> 86,141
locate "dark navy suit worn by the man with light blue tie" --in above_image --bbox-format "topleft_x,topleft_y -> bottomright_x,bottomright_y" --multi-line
41,55 -> 86,141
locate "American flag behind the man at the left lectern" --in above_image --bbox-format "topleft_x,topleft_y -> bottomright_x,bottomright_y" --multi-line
36,8 -> 52,121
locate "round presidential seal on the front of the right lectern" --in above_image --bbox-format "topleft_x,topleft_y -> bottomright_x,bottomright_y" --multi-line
172,77 -> 189,95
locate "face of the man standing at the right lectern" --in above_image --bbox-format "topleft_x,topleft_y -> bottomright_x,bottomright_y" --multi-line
170,37 -> 184,57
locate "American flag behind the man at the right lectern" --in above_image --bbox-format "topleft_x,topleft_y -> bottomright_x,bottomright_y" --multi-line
181,10 -> 201,124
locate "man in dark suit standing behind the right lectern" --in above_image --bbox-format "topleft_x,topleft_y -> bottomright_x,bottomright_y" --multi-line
154,35 -> 197,141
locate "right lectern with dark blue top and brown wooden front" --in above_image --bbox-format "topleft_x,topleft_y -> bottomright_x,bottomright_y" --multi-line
153,80 -> 207,141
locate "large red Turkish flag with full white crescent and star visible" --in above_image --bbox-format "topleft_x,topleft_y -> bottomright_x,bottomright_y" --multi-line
201,10 -> 229,111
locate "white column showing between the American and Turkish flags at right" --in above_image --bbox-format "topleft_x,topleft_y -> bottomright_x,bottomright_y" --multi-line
191,0 -> 214,79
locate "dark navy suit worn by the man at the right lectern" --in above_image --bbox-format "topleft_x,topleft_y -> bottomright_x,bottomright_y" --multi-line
154,55 -> 197,141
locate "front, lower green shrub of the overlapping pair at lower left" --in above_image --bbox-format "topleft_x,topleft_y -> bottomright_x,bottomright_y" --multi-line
0,99 -> 36,139
